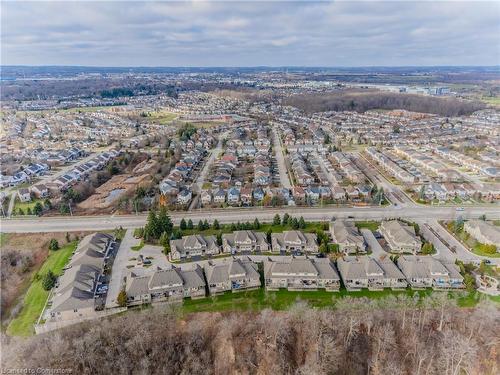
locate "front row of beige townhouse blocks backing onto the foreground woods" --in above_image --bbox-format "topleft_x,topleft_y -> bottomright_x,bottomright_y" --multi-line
125,255 -> 464,306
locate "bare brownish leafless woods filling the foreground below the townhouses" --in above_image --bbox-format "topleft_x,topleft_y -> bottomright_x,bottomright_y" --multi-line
2,300 -> 500,375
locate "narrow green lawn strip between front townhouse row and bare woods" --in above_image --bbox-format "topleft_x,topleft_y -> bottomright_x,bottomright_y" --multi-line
182,288 -> 492,314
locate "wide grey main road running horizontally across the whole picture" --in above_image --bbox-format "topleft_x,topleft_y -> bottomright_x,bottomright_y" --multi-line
0,207 -> 500,233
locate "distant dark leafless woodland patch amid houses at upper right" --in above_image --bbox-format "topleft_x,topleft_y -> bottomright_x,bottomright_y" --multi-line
284,90 -> 485,117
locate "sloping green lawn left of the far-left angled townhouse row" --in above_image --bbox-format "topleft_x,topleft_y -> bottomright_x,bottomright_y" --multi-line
7,241 -> 77,336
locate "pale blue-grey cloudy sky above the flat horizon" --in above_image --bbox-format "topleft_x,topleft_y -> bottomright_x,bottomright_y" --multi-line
0,0 -> 500,67
